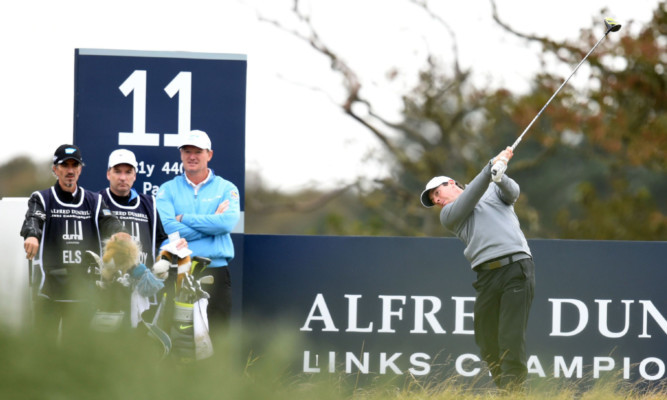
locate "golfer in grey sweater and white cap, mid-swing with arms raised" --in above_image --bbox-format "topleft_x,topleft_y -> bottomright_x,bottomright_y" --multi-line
421,147 -> 535,390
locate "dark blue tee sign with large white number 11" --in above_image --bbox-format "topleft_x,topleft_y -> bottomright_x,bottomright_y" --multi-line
74,49 -> 247,211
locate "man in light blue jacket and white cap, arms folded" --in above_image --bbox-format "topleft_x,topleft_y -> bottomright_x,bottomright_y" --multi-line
156,130 -> 241,324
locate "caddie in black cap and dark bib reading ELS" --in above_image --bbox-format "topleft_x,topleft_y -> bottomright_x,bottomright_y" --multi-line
21,144 -> 127,342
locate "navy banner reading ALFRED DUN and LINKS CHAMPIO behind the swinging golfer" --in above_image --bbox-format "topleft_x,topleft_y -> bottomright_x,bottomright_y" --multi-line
243,235 -> 667,382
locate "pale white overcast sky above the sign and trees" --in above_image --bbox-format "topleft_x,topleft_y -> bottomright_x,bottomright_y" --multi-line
0,0 -> 658,190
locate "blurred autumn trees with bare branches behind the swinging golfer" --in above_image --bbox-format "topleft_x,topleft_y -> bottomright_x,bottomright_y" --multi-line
248,0 -> 665,238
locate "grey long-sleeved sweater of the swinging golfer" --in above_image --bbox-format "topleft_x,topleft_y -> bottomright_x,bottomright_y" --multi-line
440,163 -> 531,268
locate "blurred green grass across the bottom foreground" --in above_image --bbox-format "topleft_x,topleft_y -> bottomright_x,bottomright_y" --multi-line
0,326 -> 667,400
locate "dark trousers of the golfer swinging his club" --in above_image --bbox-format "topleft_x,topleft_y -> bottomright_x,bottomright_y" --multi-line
473,258 -> 535,389
